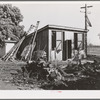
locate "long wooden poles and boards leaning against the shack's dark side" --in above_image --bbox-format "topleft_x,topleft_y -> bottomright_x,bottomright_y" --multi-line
2,21 -> 39,61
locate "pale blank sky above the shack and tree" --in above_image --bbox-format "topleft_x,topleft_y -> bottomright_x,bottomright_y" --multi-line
1,1 -> 100,45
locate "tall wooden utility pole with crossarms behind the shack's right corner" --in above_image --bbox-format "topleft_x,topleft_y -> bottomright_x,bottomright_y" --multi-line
81,4 -> 93,56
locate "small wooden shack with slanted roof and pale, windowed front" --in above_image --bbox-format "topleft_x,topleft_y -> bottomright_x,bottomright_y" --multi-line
17,25 -> 86,61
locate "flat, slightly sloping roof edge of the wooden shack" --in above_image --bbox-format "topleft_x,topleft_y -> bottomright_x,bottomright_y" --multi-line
38,25 -> 88,33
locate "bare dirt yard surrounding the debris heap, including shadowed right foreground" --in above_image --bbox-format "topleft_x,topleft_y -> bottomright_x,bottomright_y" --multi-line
0,56 -> 100,90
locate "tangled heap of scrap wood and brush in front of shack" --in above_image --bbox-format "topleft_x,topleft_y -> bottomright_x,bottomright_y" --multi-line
22,51 -> 100,89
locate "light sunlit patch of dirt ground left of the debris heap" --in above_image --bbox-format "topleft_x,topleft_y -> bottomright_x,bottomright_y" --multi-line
0,60 -> 41,90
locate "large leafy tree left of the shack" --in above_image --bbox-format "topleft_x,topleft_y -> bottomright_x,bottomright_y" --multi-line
0,4 -> 25,41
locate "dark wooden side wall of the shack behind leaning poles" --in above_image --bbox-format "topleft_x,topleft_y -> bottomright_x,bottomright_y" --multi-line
17,30 -> 48,59
